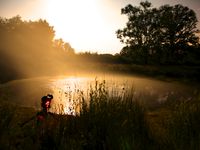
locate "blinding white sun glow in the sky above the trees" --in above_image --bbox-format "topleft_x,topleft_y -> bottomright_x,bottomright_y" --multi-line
46,0 -> 107,49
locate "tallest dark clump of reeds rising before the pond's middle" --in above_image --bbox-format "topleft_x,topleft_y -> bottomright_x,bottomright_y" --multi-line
77,81 -> 151,149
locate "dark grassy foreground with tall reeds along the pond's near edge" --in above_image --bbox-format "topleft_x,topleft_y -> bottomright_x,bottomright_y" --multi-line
0,81 -> 200,150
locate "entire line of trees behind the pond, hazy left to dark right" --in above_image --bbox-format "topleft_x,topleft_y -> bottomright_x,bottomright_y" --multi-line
0,1 -> 200,82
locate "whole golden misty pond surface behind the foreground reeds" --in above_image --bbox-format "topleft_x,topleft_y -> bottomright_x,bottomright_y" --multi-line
0,74 -> 199,114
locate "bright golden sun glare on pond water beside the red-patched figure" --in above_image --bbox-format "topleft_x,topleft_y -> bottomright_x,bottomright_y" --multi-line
51,77 -> 90,115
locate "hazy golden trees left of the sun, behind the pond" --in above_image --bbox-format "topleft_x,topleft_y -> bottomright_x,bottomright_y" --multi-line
0,16 -> 74,81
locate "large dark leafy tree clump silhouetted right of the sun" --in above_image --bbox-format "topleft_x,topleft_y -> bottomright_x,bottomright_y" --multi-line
116,1 -> 199,64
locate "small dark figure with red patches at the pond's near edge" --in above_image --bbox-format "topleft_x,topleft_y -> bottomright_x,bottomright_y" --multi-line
37,94 -> 53,124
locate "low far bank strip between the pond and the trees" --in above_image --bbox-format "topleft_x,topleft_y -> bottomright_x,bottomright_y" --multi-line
0,62 -> 200,84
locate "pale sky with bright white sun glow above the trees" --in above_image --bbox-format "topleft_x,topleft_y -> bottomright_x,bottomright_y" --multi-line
0,0 -> 200,54
